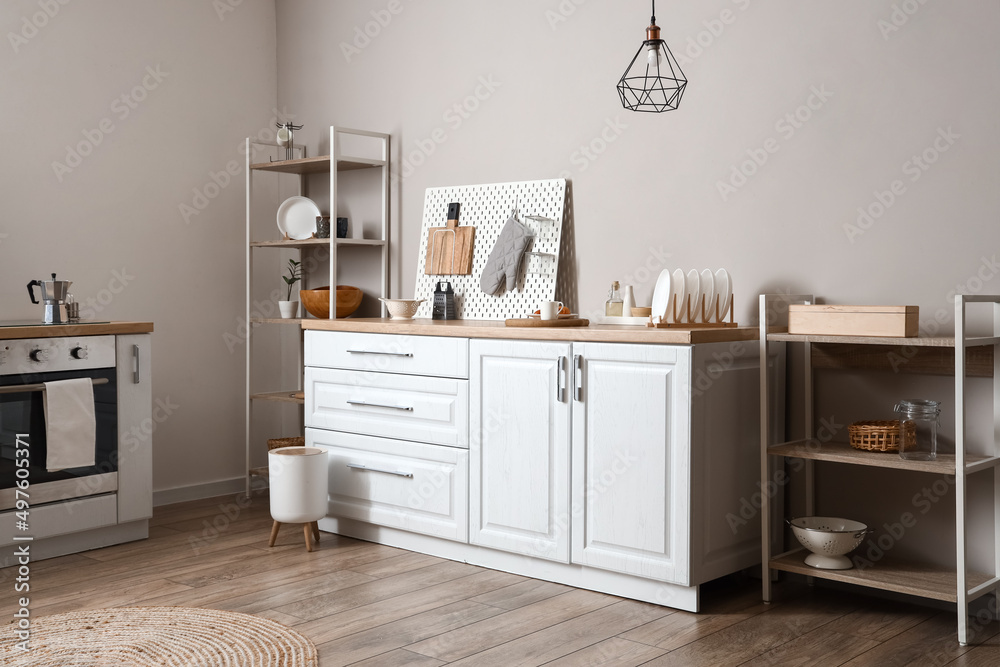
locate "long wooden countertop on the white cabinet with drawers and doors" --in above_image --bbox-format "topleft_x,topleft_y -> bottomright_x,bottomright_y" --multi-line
302,318 -> 759,345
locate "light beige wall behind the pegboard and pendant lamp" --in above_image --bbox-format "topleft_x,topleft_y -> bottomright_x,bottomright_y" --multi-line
277,0 -> 1000,566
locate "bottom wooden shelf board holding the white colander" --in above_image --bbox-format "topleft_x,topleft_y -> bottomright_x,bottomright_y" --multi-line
770,549 -> 991,602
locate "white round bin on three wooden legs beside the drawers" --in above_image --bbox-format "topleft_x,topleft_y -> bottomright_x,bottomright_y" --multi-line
267,447 -> 328,551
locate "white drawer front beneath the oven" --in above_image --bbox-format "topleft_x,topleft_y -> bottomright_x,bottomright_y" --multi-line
0,496 -> 118,546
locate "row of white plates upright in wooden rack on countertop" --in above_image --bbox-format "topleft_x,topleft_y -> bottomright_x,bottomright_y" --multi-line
651,269 -> 733,324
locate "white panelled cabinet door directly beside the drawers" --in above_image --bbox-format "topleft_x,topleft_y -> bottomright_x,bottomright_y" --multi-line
469,340 -> 572,563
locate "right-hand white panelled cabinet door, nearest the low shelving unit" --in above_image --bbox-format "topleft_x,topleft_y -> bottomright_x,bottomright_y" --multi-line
572,343 -> 691,585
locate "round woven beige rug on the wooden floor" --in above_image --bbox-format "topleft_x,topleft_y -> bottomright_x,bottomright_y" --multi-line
0,607 -> 318,667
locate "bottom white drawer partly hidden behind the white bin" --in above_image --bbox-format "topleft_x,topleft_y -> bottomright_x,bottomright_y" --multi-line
306,428 -> 469,542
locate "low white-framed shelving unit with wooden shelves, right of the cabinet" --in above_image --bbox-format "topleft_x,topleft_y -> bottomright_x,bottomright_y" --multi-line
760,294 -> 1000,646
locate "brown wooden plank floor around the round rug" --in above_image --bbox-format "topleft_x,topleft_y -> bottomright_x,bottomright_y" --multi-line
0,496 -> 1000,667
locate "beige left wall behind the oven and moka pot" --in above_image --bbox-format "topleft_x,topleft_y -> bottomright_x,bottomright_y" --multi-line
0,0 -> 276,491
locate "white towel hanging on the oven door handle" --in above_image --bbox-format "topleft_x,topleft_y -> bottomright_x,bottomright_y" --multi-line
43,378 -> 97,472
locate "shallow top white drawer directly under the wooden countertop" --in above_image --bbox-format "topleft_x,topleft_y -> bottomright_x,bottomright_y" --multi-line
305,330 -> 469,378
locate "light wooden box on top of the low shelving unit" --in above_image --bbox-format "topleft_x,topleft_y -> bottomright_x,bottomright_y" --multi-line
788,305 -> 920,338
